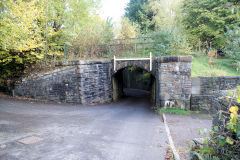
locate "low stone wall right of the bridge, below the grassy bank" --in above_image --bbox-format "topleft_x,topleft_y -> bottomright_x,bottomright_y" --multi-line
191,76 -> 240,112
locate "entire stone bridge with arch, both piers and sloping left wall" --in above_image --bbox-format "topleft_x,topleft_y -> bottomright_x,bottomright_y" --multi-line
13,56 -> 240,109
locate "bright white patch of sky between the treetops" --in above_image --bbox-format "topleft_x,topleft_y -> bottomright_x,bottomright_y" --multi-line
100,0 -> 130,23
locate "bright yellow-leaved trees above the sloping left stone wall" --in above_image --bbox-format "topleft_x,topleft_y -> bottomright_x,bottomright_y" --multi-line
0,0 -> 104,81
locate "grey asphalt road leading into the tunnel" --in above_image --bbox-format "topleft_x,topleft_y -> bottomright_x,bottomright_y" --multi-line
0,97 -> 168,160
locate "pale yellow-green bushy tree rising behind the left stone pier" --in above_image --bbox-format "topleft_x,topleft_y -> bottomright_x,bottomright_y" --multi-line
69,16 -> 114,59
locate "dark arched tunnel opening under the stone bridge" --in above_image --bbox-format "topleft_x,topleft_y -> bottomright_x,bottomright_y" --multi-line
112,66 -> 156,107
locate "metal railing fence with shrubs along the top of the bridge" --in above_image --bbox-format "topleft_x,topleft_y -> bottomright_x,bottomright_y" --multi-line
64,37 -> 161,59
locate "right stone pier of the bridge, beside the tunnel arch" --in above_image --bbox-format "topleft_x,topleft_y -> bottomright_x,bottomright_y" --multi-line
156,56 -> 192,109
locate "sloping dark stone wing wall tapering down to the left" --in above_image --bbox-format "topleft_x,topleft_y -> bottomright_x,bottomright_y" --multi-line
14,66 -> 79,102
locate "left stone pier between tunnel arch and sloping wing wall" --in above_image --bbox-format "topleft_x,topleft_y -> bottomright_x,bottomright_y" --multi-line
78,60 -> 113,104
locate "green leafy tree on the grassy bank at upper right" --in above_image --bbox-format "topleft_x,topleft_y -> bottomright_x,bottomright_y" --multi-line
182,0 -> 239,49
